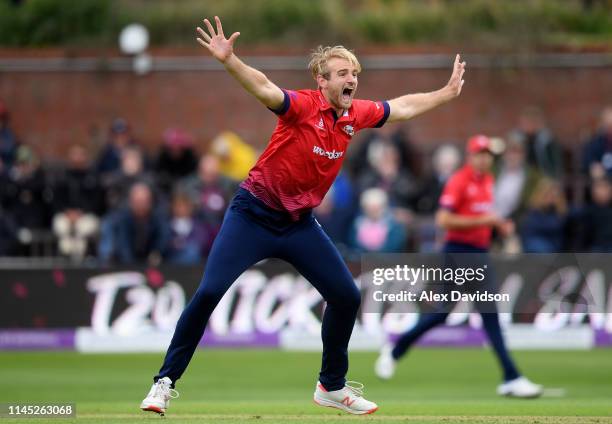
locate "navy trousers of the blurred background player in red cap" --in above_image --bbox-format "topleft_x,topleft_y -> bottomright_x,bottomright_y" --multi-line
392,243 -> 520,381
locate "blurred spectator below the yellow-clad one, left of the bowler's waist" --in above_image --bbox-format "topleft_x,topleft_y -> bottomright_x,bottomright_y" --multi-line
180,154 -> 236,229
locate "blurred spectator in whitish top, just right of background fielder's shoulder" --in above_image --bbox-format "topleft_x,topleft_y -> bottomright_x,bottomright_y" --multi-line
494,134 -> 541,219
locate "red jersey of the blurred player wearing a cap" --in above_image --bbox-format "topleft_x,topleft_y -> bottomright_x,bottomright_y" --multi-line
440,165 -> 494,249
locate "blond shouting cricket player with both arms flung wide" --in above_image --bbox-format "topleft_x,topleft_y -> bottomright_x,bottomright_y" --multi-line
141,17 -> 465,414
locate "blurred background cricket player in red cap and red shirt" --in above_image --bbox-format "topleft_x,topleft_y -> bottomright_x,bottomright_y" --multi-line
374,135 -> 542,398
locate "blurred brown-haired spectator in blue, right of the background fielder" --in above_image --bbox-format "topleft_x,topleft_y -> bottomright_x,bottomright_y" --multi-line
520,178 -> 567,253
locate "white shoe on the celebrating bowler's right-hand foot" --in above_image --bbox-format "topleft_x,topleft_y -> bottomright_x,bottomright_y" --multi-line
314,381 -> 378,415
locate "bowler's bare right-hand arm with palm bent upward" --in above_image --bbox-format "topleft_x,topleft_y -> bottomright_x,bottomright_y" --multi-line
387,55 -> 465,122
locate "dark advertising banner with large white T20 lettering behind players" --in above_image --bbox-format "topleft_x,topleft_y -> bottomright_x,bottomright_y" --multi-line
0,255 -> 612,352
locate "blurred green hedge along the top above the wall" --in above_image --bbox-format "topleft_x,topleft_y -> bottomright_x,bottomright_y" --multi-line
0,0 -> 612,47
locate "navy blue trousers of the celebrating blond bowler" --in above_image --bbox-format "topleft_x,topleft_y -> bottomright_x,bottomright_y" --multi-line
154,188 -> 361,390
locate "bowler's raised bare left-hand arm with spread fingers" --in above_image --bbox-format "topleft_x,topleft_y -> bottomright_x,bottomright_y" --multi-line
196,16 -> 285,110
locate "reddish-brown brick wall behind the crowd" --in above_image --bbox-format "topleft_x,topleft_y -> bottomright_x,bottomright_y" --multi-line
0,56 -> 612,158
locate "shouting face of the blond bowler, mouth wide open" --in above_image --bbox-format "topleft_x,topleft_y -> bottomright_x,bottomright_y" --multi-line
319,57 -> 358,109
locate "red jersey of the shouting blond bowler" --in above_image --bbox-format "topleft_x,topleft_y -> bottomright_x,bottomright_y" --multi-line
240,90 -> 389,220
